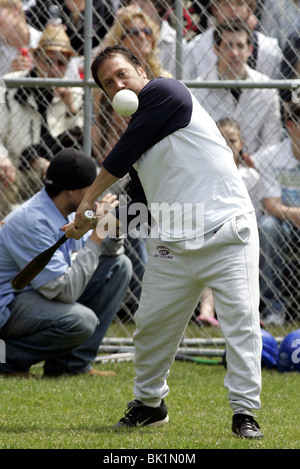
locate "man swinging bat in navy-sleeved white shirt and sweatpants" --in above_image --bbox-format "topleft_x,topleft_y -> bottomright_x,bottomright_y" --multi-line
64,46 -> 263,438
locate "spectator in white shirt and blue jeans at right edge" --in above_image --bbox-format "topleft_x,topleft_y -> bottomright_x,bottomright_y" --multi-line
257,103 -> 300,325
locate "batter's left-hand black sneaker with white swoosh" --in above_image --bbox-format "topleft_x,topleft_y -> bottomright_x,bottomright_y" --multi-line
114,399 -> 169,428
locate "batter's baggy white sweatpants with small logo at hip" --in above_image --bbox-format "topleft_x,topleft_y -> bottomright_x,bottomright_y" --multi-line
133,213 -> 262,414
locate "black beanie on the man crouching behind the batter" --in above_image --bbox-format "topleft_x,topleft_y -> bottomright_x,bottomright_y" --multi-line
45,148 -> 97,190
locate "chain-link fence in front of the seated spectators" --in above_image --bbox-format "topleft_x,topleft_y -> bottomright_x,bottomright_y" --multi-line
0,0 -> 300,354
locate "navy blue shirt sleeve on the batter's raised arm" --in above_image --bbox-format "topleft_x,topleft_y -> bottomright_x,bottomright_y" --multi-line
103,77 -> 192,178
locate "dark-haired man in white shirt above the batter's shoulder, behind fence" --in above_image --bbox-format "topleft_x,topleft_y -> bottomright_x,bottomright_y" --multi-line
194,20 -> 282,155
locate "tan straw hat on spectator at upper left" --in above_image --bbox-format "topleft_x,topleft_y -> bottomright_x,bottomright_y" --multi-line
33,24 -> 75,57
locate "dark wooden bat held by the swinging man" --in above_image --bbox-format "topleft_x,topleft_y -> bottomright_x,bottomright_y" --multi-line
11,210 -> 95,291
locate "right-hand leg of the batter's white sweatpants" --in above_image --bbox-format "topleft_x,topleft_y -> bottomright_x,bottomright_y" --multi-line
210,214 -> 262,414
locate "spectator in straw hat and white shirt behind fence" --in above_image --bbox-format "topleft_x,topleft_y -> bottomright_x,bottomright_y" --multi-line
0,25 -> 83,217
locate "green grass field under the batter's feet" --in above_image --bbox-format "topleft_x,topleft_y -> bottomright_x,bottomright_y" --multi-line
0,362 -> 300,450
